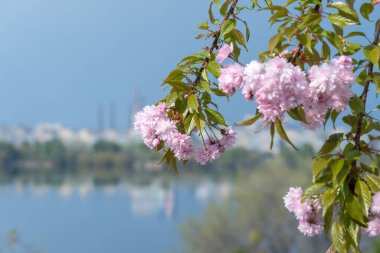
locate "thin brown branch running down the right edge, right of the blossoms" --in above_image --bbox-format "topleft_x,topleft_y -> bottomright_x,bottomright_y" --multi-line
354,24 -> 380,151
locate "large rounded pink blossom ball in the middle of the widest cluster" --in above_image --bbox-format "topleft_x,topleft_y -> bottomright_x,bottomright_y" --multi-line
242,57 -> 308,122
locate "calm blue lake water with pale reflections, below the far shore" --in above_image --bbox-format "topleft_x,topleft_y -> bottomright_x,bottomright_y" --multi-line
0,174 -> 231,253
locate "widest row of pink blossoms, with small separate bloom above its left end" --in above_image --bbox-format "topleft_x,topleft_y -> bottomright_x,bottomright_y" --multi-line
216,45 -> 354,129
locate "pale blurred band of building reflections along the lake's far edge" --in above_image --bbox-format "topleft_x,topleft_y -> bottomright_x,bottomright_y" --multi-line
0,171 -> 232,220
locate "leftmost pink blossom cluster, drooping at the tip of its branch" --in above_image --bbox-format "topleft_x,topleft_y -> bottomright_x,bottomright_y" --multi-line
134,103 -> 236,165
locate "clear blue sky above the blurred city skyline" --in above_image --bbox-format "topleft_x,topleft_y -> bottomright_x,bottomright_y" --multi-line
0,0 -> 378,128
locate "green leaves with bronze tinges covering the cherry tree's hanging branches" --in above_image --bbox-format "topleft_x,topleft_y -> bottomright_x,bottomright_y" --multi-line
157,0 -> 380,249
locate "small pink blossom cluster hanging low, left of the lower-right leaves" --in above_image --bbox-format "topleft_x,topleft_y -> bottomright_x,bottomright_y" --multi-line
284,187 -> 323,237
